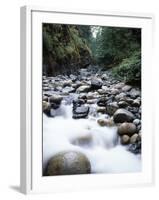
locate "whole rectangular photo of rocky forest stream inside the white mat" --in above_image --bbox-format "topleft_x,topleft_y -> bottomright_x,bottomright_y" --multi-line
42,23 -> 142,176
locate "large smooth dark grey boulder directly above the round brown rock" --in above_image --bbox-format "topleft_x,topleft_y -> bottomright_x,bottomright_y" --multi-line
113,108 -> 135,123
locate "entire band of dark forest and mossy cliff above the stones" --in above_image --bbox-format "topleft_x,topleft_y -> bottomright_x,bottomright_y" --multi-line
43,24 -> 141,85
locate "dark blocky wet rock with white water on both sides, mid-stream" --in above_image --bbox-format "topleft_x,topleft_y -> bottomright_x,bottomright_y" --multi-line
73,105 -> 89,119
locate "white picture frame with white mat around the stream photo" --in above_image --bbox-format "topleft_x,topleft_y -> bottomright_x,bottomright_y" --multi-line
21,6 -> 154,194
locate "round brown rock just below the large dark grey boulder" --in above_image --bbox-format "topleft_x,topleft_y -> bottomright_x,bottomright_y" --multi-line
118,122 -> 136,137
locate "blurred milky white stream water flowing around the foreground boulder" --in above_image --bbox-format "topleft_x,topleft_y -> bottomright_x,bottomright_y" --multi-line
43,102 -> 141,173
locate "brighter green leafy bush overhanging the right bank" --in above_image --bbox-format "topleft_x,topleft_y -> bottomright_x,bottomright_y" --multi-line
112,51 -> 141,84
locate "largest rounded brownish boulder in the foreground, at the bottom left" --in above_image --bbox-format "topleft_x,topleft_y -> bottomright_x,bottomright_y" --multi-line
45,151 -> 91,176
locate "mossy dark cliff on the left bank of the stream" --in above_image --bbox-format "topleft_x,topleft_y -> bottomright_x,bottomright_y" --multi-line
43,24 -> 91,76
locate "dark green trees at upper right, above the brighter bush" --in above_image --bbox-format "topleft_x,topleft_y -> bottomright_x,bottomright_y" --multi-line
95,27 -> 141,65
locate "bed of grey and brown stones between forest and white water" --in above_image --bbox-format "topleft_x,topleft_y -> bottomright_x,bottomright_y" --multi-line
42,67 -> 141,173
